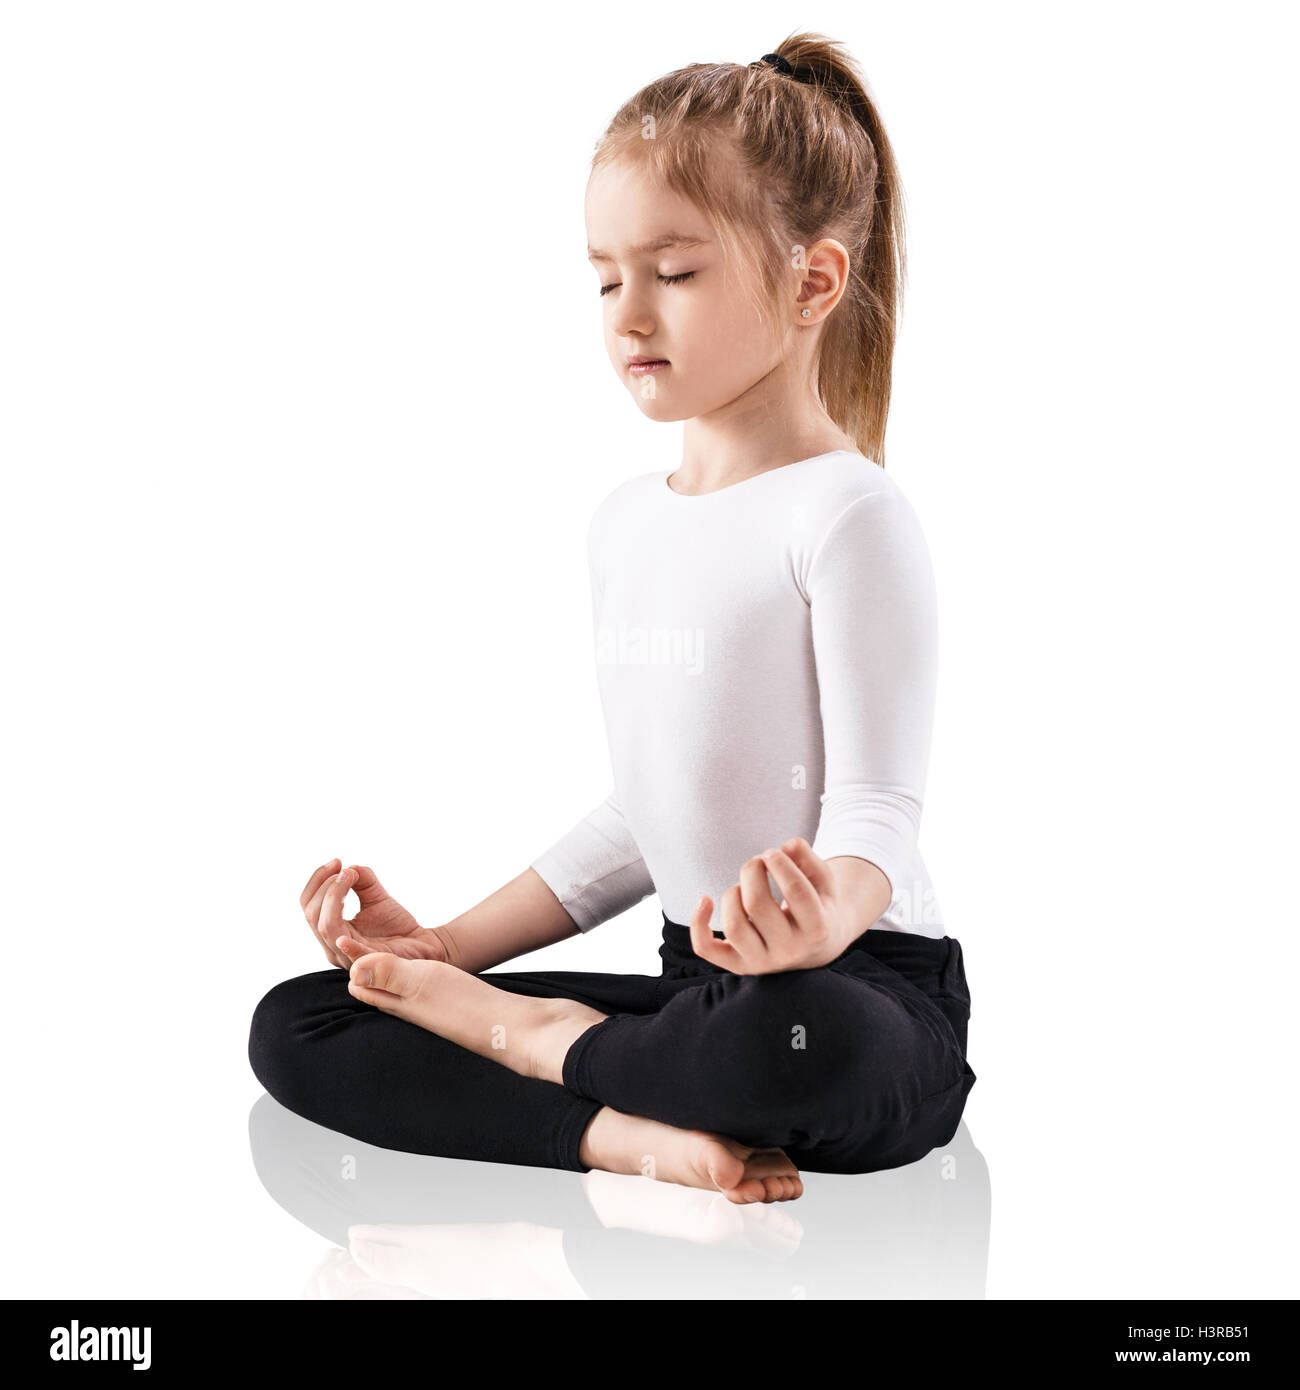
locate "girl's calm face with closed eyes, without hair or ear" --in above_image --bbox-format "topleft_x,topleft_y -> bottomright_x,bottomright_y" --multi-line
587,161 -> 784,421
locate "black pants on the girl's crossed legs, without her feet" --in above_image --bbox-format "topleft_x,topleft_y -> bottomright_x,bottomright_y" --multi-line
249,917 -> 976,1173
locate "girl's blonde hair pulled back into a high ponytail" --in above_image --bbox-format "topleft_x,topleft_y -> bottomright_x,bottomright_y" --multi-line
592,33 -> 907,467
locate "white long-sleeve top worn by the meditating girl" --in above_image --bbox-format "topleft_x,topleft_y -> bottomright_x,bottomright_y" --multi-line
533,450 -> 944,937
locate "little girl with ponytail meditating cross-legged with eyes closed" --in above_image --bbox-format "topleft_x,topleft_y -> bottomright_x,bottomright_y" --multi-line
249,35 -> 975,1202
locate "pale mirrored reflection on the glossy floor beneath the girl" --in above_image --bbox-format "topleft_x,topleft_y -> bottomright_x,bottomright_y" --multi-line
249,1095 -> 991,1298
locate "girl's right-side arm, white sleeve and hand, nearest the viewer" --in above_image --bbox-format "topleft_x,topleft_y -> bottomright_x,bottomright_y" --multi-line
691,482 -> 937,974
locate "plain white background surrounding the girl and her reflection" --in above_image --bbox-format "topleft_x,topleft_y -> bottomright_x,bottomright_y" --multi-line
0,0 -> 1300,1298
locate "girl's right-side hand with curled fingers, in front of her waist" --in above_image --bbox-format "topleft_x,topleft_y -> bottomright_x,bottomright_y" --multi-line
691,835 -> 858,974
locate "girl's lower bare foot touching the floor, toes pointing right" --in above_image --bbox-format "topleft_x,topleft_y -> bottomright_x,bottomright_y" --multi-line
578,1105 -> 804,1202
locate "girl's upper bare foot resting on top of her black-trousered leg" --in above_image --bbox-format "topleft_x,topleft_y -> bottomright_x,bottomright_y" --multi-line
339,956 -> 608,1084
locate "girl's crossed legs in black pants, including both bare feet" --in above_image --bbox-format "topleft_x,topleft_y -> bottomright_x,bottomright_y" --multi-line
249,956 -> 973,1202
